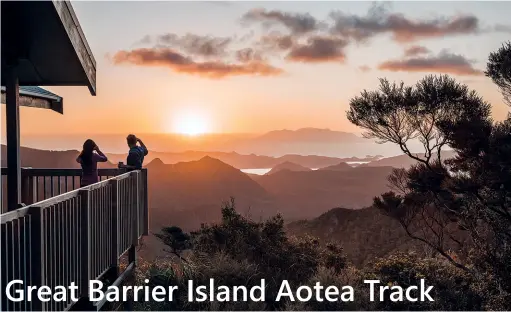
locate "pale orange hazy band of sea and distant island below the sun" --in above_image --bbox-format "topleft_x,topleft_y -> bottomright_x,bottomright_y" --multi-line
9,128 -> 432,157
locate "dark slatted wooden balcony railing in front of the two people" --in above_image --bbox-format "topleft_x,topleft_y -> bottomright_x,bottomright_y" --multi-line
0,169 -> 148,311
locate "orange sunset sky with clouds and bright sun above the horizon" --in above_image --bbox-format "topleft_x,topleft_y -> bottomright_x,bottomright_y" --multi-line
2,1 -> 511,134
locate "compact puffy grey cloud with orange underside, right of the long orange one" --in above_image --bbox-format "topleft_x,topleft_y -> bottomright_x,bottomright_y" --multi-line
286,36 -> 348,63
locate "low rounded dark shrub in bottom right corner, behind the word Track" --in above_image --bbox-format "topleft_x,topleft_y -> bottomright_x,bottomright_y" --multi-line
365,253 -> 506,311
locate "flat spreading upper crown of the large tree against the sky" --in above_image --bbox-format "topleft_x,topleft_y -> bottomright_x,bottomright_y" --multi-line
347,75 -> 490,165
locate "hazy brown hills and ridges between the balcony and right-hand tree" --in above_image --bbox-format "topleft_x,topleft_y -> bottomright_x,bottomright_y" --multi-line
1,145 -> 436,258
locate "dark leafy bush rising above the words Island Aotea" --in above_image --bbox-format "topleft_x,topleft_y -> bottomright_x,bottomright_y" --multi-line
153,199 -> 347,309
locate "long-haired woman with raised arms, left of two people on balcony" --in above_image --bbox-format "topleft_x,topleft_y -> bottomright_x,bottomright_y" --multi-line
76,139 -> 108,187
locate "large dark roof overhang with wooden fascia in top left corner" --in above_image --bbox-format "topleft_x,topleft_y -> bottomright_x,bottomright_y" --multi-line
1,1 -> 96,95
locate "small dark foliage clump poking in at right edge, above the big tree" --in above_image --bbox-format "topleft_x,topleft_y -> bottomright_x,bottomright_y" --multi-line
485,41 -> 511,106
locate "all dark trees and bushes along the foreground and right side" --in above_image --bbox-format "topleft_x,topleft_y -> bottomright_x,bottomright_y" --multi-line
136,44 -> 511,310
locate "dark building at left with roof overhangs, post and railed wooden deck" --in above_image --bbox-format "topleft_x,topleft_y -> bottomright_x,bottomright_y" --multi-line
0,1 -> 148,311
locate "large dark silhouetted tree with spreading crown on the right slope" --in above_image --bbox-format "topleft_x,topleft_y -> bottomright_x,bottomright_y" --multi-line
347,44 -> 511,298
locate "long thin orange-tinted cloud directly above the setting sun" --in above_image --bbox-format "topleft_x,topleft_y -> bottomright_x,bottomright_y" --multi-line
112,48 -> 283,79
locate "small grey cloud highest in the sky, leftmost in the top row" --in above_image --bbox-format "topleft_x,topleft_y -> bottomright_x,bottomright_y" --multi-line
241,9 -> 319,34
